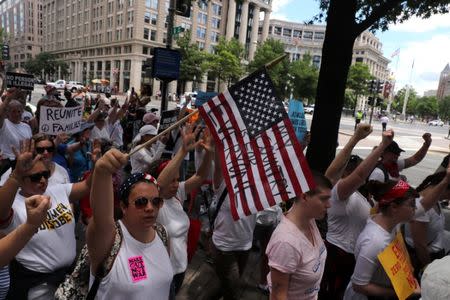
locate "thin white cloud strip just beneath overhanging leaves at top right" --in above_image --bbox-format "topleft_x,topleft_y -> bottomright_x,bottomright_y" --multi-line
389,13 -> 450,32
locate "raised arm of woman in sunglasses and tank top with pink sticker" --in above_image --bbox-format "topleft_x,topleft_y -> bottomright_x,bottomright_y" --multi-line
86,149 -> 128,272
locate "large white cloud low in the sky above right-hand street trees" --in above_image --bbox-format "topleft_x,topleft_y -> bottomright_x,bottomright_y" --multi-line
390,34 -> 450,95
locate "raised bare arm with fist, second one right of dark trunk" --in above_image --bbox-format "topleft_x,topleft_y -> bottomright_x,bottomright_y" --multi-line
337,129 -> 394,200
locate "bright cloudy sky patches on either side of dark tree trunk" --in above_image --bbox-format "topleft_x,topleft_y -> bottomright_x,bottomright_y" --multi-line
271,0 -> 450,95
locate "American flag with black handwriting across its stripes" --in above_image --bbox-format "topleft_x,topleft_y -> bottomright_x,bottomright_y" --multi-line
199,69 -> 314,220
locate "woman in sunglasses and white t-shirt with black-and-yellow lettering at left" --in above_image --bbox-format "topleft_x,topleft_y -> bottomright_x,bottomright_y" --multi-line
0,141 -> 90,299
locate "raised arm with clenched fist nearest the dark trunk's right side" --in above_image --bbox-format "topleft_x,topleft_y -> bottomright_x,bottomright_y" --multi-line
325,124 -> 372,185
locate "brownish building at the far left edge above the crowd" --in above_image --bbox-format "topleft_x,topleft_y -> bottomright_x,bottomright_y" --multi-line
0,0 -> 43,69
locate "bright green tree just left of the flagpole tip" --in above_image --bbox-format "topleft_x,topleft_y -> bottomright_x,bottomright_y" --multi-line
207,38 -> 244,86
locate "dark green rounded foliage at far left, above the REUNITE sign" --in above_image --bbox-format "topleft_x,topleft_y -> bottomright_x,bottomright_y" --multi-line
25,52 -> 69,77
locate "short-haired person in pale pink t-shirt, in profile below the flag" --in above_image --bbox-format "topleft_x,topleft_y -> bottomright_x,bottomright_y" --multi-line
266,173 -> 332,300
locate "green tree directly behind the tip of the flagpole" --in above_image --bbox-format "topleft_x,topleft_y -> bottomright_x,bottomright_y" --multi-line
248,39 -> 290,99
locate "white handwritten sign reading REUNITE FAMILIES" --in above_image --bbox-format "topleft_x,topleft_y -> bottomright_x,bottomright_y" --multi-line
39,105 -> 84,135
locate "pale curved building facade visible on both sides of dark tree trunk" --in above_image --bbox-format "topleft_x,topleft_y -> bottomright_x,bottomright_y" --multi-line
260,20 -> 390,80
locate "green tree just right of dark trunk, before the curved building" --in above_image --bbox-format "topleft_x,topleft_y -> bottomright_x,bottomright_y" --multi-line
346,62 -> 374,110
